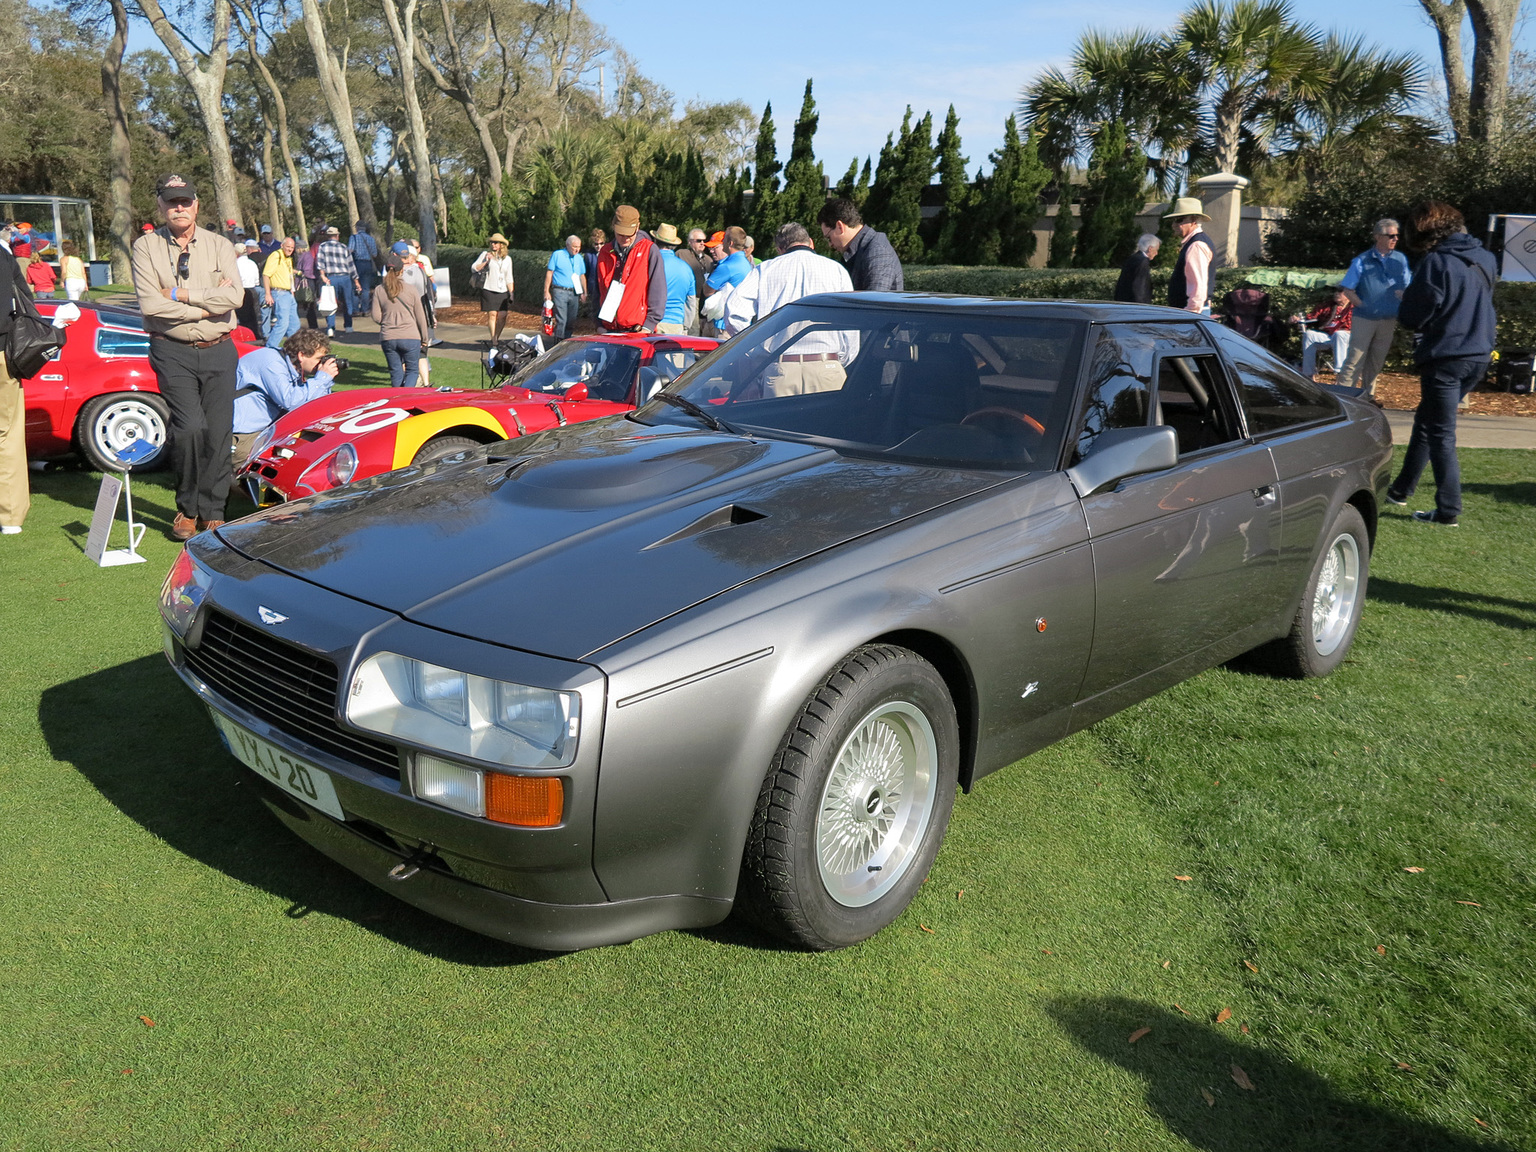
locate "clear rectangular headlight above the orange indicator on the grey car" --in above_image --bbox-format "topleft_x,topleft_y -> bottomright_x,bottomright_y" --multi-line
347,653 -> 581,768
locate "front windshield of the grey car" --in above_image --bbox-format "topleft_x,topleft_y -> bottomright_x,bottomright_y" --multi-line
639,304 -> 1086,468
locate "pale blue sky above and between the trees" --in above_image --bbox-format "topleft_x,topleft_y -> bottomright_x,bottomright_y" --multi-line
584,0 -> 1533,171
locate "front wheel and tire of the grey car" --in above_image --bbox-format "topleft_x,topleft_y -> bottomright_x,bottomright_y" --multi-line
737,644 -> 960,951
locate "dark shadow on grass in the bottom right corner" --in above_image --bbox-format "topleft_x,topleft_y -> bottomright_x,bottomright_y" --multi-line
1046,997 -> 1510,1152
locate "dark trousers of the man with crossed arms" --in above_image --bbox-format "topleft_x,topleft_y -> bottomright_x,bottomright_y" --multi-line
149,339 -> 240,521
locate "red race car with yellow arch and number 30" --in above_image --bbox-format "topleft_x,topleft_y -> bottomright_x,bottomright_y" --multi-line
237,333 -> 719,505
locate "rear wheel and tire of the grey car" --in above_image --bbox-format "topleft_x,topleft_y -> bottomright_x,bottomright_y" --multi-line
1250,504 -> 1370,680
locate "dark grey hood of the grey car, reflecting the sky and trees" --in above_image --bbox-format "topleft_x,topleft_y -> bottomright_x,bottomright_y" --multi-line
218,419 -> 1008,659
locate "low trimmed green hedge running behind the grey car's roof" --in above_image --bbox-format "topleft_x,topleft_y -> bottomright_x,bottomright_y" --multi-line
903,266 -> 1536,372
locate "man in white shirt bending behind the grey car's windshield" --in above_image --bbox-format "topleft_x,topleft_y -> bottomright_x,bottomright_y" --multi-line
725,221 -> 857,396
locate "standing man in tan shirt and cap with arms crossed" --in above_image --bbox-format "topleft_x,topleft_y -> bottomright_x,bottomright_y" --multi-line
134,174 -> 246,541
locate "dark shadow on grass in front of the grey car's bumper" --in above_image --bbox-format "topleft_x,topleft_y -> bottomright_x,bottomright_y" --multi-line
38,654 -> 551,968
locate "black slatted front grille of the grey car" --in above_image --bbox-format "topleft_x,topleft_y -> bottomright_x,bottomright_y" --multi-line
186,611 -> 399,780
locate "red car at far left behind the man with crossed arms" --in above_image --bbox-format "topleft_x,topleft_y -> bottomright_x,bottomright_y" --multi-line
23,300 -> 258,472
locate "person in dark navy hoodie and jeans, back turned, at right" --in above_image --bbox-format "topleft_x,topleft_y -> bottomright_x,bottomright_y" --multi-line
1387,200 -> 1499,527
